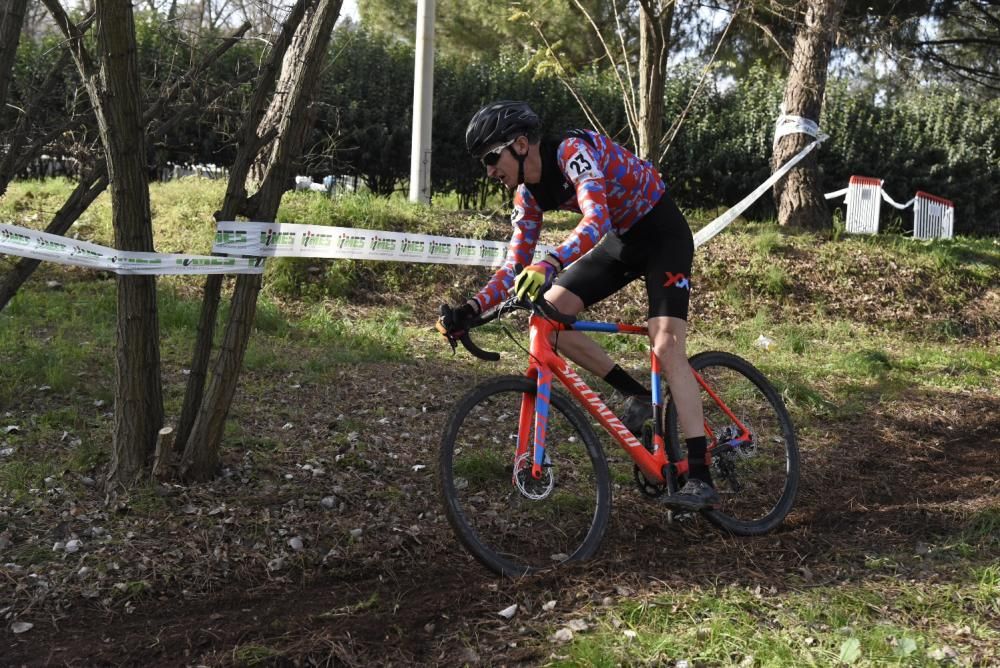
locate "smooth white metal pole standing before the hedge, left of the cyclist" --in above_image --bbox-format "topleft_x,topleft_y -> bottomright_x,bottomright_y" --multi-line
410,0 -> 434,204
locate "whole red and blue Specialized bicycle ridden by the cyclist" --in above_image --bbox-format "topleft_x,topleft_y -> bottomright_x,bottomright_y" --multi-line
438,298 -> 799,576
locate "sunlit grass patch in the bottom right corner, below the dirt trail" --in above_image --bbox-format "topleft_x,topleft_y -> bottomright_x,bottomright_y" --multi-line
555,572 -> 1000,666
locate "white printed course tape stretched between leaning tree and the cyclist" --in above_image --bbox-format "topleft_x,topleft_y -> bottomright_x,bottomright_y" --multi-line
212,222 -> 552,267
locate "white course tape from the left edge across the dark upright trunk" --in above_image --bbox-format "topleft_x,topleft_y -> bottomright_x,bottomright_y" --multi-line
0,224 -> 264,274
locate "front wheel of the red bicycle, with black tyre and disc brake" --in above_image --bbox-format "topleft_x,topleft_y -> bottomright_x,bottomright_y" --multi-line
438,376 -> 611,576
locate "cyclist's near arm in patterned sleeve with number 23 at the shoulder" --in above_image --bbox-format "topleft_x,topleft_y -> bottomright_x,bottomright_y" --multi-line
552,139 -> 611,267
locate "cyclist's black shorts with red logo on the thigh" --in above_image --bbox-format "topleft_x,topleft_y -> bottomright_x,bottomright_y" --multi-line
556,193 -> 694,320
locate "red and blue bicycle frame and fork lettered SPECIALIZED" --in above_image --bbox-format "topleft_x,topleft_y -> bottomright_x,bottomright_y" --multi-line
515,314 -> 752,485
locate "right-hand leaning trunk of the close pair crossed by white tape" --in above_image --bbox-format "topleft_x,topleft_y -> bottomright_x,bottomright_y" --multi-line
174,0 -> 342,480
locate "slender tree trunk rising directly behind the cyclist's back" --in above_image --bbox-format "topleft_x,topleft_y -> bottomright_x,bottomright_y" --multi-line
637,0 -> 674,160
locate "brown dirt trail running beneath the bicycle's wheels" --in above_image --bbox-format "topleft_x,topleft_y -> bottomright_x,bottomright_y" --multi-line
0,376 -> 1000,666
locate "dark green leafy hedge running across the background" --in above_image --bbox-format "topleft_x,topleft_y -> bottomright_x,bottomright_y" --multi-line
7,21 -> 1000,235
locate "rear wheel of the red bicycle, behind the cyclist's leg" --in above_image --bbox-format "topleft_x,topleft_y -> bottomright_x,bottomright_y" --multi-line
667,352 -> 799,536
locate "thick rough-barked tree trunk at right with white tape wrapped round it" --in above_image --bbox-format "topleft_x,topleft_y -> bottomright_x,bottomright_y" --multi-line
771,0 -> 844,230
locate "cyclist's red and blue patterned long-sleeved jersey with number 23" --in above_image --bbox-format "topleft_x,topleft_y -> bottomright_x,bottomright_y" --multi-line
475,130 -> 665,311
